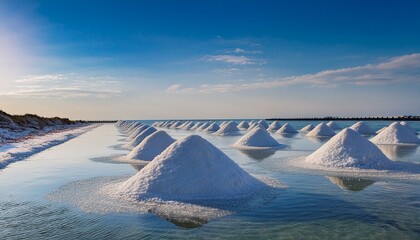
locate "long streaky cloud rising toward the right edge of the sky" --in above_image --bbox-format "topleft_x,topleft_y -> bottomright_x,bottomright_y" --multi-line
166,53 -> 420,94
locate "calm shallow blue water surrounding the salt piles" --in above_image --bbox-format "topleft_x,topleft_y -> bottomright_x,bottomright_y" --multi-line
0,122 -> 420,239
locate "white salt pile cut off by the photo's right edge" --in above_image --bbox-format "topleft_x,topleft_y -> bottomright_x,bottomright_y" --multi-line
371,122 -> 420,144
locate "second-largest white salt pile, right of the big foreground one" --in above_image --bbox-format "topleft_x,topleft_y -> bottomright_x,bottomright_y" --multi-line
305,128 -> 391,169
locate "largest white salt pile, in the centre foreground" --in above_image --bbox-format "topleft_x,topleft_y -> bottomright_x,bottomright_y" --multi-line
117,135 -> 266,200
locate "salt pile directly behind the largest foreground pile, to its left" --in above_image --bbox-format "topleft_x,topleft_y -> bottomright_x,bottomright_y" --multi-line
127,131 -> 175,161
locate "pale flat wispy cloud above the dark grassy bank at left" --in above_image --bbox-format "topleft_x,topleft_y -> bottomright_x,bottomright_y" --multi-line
0,73 -> 122,98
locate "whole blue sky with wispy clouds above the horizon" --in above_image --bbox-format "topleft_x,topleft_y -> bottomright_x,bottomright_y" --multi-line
0,0 -> 420,119
